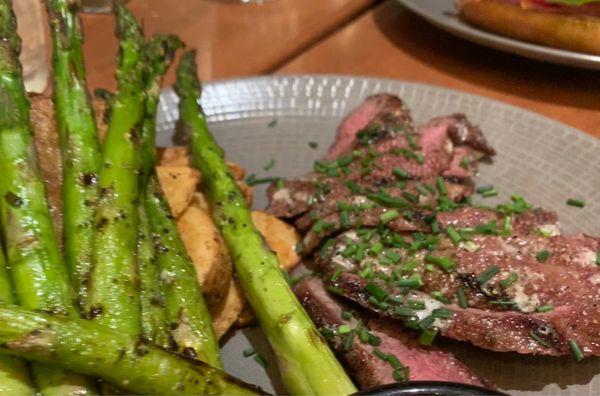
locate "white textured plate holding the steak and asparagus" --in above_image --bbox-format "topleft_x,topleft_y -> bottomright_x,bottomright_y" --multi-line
158,76 -> 600,395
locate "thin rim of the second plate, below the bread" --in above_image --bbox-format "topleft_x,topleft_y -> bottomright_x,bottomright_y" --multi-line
398,0 -> 600,70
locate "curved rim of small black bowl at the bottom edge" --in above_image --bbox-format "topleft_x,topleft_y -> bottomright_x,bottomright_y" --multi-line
354,381 -> 507,396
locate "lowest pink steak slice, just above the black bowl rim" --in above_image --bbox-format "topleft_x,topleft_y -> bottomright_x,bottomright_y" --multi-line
295,278 -> 485,389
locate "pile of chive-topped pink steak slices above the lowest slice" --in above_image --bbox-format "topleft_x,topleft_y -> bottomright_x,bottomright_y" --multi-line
268,92 -> 600,368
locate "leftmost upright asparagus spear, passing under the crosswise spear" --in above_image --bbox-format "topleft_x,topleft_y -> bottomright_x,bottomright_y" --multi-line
0,0 -> 95,395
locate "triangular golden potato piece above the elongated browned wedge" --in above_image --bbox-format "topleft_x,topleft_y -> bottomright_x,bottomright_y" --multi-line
156,166 -> 200,218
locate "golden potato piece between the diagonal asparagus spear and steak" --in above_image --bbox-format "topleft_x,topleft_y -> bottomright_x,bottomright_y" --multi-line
252,211 -> 300,271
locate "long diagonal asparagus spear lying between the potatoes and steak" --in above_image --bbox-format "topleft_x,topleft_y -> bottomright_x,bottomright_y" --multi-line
175,51 -> 356,395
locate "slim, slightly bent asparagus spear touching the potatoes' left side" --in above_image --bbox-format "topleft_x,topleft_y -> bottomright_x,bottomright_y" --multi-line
142,37 -> 221,367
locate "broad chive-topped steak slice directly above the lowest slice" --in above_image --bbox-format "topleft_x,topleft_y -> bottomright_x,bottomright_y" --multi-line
324,236 -> 600,356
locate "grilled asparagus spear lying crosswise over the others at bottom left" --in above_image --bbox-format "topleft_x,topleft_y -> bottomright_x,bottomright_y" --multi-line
0,305 -> 259,395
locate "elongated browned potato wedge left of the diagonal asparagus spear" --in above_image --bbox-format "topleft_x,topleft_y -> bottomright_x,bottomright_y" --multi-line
177,205 -> 233,306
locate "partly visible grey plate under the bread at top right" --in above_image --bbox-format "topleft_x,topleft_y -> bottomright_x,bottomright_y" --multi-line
398,0 -> 600,70
